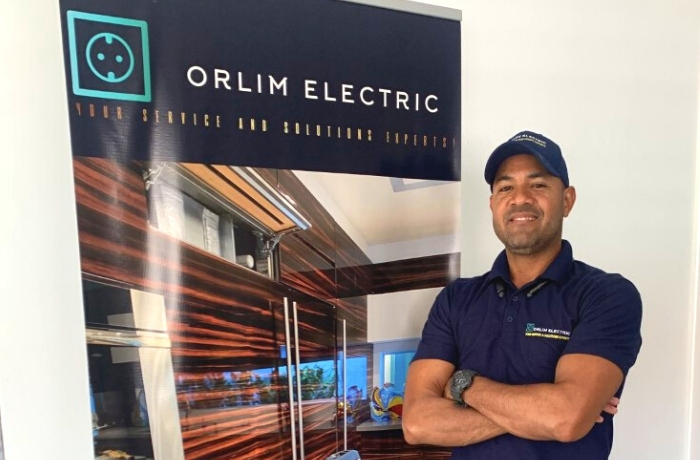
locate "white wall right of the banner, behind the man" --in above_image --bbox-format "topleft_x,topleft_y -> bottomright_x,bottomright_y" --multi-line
418,0 -> 700,460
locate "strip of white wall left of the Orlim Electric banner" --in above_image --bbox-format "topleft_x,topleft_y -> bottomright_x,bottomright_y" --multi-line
0,0 -> 94,460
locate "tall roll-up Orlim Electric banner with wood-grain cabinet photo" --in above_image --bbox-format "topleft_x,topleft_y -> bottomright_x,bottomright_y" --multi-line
60,0 -> 461,460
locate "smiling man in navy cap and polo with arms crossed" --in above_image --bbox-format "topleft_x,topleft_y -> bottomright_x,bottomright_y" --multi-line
403,131 -> 642,460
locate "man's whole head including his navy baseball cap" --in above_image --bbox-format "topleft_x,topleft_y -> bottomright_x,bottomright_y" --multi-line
484,131 -> 576,255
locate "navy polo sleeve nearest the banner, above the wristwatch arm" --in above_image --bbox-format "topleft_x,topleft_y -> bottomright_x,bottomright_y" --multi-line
413,284 -> 458,365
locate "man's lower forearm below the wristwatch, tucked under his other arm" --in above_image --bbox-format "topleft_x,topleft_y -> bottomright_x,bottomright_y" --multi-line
402,397 -> 506,447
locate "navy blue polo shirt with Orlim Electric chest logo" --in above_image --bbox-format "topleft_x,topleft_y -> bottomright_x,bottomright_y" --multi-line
414,241 -> 642,460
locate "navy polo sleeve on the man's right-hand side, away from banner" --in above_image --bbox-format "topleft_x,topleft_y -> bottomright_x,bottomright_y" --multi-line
563,275 -> 642,375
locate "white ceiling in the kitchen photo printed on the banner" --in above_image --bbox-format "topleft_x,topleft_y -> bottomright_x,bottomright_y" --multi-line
294,171 -> 460,255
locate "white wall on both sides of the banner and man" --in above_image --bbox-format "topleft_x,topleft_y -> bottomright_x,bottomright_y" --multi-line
0,0 -> 700,460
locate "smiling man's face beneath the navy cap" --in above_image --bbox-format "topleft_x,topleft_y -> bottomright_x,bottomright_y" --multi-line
490,154 -> 576,255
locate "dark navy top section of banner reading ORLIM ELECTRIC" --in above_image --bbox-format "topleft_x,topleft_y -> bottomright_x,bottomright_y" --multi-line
61,0 -> 460,180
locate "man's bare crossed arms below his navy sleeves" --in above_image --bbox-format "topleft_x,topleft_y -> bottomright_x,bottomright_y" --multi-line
403,354 -> 623,446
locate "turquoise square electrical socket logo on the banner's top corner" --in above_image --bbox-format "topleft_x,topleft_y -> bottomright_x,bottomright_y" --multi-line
68,11 -> 151,102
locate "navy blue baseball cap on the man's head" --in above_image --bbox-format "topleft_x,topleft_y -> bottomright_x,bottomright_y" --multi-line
484,131 -> 569,187
